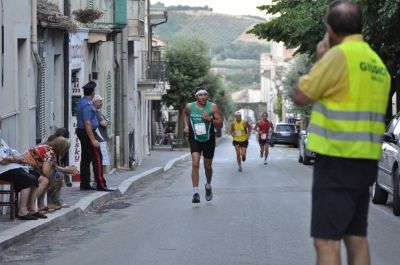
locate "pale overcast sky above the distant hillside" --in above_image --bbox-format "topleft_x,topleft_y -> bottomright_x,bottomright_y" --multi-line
157,0 -> 270,17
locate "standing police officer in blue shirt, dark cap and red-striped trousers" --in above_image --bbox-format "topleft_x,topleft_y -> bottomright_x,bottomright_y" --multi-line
76,81 -> 112,191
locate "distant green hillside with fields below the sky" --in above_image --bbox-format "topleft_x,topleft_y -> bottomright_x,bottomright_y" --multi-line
153,2 -> 270,90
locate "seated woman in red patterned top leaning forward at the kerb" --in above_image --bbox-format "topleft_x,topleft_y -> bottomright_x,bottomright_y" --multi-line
24,136 -> 78,214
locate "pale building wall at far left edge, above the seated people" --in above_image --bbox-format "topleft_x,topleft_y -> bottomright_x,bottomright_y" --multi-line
0,0 -> 37,151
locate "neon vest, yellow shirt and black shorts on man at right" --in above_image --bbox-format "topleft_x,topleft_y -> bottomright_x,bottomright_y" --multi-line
299,34 -> 390,240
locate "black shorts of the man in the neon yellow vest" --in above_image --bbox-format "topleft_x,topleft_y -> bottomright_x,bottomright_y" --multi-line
311,155 -> 378,240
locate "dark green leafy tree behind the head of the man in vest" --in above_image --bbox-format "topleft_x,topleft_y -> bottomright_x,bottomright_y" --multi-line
249,0 -> 400,116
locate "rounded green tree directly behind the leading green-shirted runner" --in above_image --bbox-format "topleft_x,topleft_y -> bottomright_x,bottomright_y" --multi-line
163,37 -> 233,134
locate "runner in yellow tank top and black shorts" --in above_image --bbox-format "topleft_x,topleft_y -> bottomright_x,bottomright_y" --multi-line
231,111 -> 251,172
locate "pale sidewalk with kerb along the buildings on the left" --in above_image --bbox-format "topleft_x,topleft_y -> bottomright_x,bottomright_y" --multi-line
0,137 -> 225,251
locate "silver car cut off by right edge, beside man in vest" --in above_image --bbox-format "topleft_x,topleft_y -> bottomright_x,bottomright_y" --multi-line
372,113 -> 400,216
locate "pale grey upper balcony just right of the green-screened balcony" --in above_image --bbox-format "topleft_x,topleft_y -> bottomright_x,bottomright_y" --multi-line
127,0 -> 146,40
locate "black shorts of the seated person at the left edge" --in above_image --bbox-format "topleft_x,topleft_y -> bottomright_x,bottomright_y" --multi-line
0,167 -> 39,191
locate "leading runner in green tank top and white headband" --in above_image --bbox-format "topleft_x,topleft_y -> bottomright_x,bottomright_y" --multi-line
183,87 -> 223,203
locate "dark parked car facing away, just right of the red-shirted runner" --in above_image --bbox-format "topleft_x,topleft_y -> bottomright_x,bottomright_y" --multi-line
270,123 -> 299,147
